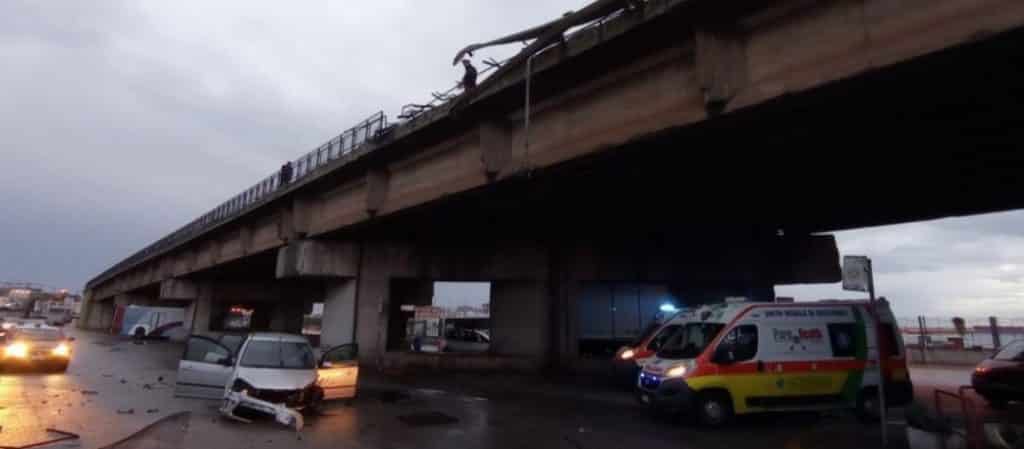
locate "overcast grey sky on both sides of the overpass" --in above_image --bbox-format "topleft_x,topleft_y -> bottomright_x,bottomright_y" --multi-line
0,0 -> 1024,317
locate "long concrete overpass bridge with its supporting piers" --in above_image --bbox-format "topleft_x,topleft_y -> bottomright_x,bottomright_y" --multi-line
82,0 -> 1024,370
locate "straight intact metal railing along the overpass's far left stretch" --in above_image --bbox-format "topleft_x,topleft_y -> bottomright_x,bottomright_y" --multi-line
87,111 -> 388,287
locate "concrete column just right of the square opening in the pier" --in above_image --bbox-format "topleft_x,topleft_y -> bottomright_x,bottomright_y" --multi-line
490,281 -> 551,363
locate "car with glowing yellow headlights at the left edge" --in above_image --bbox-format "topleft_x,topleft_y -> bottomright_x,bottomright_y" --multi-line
0,323 -> 75,372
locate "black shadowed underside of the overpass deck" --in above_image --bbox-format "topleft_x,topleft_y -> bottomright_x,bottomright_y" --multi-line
350,23 -> 1024,239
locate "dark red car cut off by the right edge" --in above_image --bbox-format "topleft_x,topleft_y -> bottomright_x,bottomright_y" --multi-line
971,340 -> 1024,407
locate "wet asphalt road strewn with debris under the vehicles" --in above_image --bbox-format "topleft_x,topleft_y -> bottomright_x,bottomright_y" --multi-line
0,330 -> 978,449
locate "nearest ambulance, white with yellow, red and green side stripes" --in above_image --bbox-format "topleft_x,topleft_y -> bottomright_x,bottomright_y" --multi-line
637,300 -> 913,425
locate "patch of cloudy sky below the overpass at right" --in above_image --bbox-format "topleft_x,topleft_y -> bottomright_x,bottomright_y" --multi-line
776,211 -> 1024,318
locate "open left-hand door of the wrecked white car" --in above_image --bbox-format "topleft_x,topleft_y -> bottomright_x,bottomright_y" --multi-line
174,335 -> 234,399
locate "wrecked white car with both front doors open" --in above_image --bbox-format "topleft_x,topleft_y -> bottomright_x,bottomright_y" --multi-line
174,332 -> 359,428
